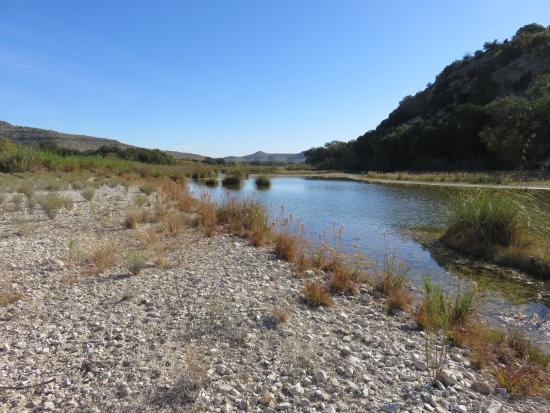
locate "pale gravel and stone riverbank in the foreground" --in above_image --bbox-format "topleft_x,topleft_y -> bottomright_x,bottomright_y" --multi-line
0,186 -> 550,413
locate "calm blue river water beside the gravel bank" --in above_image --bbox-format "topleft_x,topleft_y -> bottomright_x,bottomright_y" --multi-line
192,177 -> 550,350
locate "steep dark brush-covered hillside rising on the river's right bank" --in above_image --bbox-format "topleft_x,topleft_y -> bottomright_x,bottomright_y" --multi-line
306,24 -> 550,171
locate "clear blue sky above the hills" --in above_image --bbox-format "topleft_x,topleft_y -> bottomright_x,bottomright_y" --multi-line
0,0 -> 550,156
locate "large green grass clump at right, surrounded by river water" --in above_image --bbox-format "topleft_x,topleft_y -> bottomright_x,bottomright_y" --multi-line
441,189 -> 550,278
